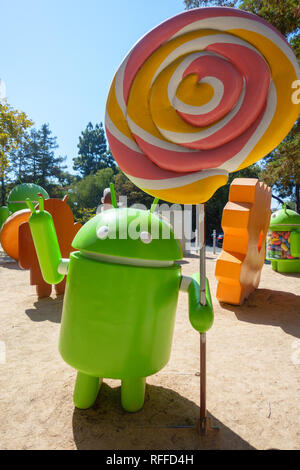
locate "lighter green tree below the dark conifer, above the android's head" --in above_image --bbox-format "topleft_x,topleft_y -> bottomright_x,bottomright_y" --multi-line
68,168 -> 114,222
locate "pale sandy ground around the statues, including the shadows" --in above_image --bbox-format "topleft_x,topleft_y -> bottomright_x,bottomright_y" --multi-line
0,248 -> 300,450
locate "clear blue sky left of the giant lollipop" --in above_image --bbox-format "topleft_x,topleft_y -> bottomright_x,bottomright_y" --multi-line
0,0 -> 184,170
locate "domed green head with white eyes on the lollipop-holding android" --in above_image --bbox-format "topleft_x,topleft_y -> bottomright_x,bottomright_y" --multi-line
72,208 -> 182,266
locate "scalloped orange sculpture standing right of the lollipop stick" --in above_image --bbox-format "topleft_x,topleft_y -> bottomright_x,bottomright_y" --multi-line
216,178 -> 272,305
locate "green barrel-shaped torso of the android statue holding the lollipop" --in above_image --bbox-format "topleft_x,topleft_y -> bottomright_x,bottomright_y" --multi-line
59,207 -> 181,378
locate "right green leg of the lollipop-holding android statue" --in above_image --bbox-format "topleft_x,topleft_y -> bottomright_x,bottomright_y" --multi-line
121,377 -> 146,412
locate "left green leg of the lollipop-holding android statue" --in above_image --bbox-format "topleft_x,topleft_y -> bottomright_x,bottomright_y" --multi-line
73,372 -> 102,410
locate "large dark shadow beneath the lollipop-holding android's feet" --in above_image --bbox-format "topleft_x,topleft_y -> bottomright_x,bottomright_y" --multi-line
73,383 -> 253,450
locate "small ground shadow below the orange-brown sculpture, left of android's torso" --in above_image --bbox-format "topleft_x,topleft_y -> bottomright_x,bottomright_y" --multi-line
25,295 -> 64,323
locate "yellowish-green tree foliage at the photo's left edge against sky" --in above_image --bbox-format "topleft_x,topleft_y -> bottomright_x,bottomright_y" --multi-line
0,100 -> 33,204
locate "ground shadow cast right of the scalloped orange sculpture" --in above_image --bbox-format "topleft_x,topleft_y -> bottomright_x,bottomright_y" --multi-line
221,289 -> 300,338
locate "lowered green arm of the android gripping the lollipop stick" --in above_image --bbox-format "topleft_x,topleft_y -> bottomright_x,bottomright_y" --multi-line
180,273 -> 214,333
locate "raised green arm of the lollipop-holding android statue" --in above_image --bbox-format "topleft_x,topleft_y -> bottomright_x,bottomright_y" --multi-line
27,197 -> 69,284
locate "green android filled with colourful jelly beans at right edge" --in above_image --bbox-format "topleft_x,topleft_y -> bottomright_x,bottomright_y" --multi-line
267,207 -> 300,273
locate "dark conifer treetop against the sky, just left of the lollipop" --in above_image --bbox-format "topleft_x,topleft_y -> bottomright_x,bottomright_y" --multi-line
73,122 -> 116,177
